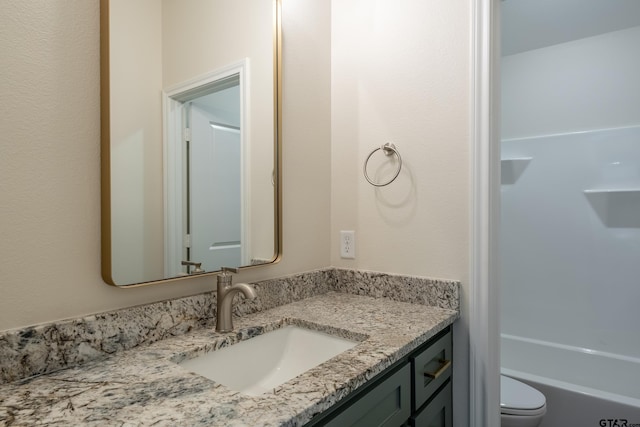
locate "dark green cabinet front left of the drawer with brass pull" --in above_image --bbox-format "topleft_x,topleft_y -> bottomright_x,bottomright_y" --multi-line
325,364 -> 411,427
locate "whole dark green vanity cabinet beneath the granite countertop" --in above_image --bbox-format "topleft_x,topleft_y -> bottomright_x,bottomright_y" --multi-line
307,327 -> 453,427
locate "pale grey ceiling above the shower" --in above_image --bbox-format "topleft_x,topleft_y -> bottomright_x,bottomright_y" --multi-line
501,0 -> 640,56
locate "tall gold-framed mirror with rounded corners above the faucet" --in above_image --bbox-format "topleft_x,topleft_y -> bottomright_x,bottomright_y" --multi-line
100,0 -> 282,287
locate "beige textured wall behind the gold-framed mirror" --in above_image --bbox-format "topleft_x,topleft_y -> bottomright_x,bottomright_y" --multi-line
0,0 -> 330,330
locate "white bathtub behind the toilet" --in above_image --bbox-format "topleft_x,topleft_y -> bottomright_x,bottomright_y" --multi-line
501,334 -> 640,427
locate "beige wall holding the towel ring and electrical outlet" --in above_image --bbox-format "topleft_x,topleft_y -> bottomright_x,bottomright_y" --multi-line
331,0 -> 471,426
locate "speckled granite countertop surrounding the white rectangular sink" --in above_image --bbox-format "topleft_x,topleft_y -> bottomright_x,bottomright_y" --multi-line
0,292 -> 458,426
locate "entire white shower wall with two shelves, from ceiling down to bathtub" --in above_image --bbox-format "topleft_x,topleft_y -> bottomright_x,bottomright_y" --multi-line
501,27 -> 640,358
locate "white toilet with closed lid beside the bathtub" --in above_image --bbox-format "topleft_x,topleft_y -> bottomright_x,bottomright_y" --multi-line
500,375 -> 547,427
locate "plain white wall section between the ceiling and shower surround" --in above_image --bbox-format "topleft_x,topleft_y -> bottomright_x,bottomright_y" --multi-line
501,26 -> 640,139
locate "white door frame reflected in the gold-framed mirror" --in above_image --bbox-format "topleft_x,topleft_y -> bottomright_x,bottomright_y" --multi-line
163,59 -> 251,277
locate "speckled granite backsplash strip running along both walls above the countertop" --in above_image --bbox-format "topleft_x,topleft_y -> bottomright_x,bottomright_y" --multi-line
0,268 -> 460,384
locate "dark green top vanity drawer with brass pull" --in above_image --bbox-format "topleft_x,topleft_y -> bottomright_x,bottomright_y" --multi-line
411,331 -> 453,411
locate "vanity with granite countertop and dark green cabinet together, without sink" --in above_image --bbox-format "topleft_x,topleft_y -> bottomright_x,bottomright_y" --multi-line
0,272 -> 459,426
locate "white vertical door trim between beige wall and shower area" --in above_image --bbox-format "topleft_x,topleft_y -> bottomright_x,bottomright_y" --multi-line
469,0 -> 500,427
